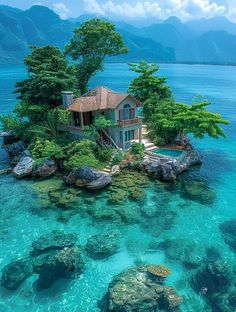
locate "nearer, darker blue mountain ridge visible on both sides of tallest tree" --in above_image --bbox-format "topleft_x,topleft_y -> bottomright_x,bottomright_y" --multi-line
0,5 -> 175,64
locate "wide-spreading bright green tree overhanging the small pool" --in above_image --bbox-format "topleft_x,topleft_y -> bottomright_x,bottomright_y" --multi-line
147,96 -> 229,143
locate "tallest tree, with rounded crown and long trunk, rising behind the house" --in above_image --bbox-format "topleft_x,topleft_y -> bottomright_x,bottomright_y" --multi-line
65,19 -> 128,94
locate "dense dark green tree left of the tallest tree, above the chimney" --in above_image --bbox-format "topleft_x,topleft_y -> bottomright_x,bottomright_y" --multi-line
15,45 -> 76,107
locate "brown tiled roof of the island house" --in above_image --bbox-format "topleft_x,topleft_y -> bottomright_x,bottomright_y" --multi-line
69,87 -> 141,112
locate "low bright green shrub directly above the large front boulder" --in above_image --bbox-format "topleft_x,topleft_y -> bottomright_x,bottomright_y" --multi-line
64,153 -> 99,170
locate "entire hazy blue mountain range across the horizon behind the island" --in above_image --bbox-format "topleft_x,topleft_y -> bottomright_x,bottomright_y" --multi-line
0,5 -> 236,64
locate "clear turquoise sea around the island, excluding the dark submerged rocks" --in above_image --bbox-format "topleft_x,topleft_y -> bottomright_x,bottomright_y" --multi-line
0,64 -> 236,312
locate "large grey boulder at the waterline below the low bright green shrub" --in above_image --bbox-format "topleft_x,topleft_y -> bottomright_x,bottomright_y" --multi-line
64,166 -> 112,190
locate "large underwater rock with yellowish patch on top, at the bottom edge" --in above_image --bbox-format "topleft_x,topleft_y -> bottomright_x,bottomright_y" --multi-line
98,265 -> 182,312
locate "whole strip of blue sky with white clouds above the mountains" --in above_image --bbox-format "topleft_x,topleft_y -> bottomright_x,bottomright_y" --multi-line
0,0 -> 236,22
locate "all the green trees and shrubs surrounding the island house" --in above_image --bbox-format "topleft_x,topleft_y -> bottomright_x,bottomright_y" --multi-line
0,19 -> 228,183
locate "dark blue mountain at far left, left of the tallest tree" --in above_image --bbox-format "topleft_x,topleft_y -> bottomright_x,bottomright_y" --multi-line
0,6 -> 74,63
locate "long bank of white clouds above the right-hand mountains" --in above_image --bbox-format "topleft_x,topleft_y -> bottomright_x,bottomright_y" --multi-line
83,0 -> 226,20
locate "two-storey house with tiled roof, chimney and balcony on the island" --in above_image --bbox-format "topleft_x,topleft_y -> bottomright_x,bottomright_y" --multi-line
62,87 -> 142,149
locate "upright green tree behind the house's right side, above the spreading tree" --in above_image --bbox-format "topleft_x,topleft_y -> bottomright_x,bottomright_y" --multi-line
128,61 -> 171,108
